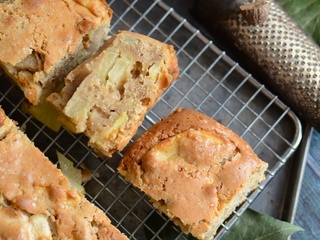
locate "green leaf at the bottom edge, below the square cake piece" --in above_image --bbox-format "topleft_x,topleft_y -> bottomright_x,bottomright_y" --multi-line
223,209 -> 304,240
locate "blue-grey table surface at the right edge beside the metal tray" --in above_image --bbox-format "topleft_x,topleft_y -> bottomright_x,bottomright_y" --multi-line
291,129 -> 320,240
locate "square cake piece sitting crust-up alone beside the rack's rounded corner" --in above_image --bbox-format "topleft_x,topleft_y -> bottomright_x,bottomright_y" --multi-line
118,109 -> 268,239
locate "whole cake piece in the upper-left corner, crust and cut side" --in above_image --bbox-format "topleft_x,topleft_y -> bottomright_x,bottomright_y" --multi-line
0,0 -> 112,104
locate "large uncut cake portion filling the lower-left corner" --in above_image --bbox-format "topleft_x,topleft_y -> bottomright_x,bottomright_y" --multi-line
0,108 -> 127,240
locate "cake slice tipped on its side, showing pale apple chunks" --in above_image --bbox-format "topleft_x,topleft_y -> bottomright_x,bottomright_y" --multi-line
47,31 -> 179,156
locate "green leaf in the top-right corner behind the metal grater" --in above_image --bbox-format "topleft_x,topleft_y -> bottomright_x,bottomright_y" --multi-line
279,0 -> 320,45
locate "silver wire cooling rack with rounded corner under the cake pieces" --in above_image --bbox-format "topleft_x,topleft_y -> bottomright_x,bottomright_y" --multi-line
0,0 -> 301,240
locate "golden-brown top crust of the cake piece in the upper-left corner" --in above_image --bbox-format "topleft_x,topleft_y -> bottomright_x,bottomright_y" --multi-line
0,0 -> 112,70
